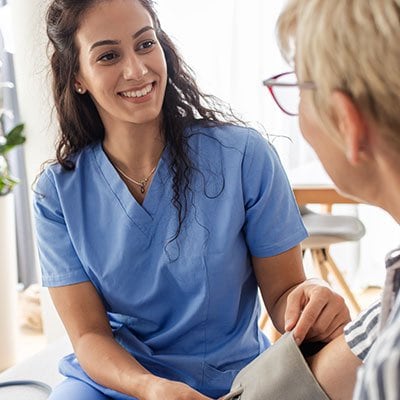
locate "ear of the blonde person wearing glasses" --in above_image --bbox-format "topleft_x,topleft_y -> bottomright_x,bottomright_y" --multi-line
332,91 -> 368,165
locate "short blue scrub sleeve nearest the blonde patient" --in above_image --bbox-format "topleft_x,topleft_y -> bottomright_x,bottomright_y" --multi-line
242,131 -> 307,257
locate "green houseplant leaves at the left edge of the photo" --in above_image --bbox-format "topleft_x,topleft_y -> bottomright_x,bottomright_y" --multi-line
0,118 -> 25,196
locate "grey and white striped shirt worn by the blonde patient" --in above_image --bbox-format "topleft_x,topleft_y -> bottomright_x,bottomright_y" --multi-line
346,249 -> 400,400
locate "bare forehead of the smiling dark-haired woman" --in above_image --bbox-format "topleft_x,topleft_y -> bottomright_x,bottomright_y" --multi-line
76,0 -> 154,47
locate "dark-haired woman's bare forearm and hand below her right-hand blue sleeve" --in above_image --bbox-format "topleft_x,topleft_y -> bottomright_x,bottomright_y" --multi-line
253,245 -> 350,343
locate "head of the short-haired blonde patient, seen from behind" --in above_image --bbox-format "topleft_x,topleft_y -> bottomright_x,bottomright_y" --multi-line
277,0 -> 400,212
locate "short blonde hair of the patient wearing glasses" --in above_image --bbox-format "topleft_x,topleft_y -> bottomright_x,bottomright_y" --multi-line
277,0 -> 400,148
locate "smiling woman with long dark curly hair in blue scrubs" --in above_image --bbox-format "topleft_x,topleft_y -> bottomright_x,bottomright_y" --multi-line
34,0 -> 349,400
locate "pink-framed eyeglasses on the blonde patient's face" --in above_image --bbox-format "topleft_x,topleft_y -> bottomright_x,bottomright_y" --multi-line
263,71 -> 316,116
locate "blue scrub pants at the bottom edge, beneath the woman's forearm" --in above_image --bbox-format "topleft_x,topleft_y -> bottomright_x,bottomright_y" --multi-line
48,378 -> 111,400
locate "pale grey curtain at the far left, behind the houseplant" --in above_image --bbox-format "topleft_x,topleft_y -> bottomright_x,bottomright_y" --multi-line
0,0 -> 38,287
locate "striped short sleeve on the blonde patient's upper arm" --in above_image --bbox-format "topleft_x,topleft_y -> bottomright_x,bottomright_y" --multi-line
344,300 -> 381,361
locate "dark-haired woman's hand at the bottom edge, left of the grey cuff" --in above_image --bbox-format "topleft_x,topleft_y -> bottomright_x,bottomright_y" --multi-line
145,375 -> 211,400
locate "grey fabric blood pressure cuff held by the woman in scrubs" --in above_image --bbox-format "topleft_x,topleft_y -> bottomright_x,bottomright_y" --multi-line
223,333 -> 329,400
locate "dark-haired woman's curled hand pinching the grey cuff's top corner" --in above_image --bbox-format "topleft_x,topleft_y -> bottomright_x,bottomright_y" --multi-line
285,279 -> 350,344
